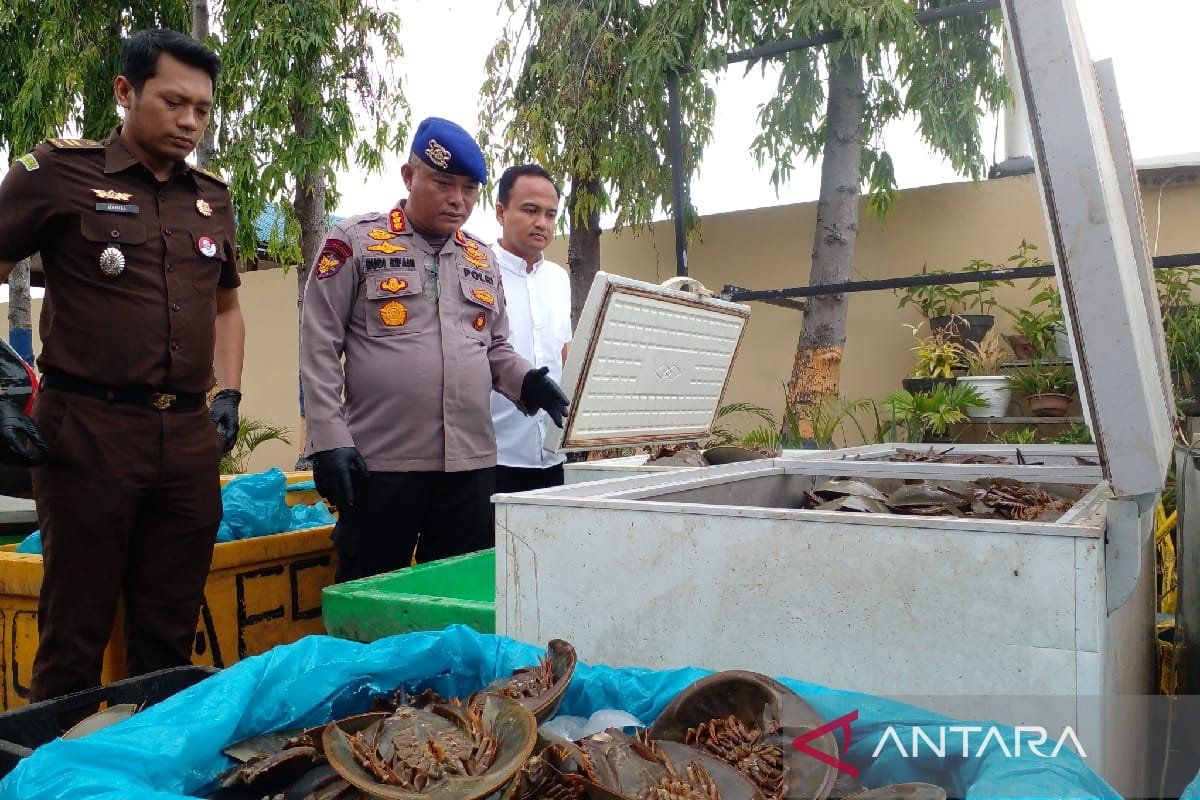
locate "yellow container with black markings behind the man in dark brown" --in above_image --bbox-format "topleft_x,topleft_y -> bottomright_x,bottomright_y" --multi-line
0,525 -> 337,710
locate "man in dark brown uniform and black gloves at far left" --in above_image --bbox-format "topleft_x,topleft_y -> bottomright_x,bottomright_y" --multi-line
0,30 -> 245,700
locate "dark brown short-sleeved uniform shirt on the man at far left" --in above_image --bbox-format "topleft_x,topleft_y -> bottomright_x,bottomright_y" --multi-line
0,128 -> 241,393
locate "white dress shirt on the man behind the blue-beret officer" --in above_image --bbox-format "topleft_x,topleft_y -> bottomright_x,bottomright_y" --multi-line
492,242 -> 571,469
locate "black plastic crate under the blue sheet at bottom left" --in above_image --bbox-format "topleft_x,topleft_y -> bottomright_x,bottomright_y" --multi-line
0,666 -> 217,777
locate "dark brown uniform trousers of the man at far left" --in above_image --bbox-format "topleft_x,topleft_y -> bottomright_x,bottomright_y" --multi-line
30,390 -> 221,700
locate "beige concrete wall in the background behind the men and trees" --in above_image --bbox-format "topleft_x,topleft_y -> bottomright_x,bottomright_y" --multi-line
9,176 -> 1200,469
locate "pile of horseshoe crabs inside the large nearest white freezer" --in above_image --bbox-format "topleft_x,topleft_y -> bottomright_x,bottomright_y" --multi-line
800,477 -> 1086,522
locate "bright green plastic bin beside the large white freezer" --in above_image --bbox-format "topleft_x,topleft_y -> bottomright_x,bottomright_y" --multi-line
322,549 -> 496,642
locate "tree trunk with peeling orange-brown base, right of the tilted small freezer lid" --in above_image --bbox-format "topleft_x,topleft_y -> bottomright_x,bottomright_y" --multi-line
787,52 -> 864,438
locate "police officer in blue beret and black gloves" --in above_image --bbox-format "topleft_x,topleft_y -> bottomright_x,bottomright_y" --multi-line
300,118 -> 566,581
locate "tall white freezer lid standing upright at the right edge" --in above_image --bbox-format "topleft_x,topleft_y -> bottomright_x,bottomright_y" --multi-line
1003,0 -> 1174,497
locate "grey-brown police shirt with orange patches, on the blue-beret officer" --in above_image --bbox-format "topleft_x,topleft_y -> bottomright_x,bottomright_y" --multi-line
300,203 -> 532,473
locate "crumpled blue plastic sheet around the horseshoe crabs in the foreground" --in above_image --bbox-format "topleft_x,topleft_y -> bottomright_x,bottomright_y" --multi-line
0,626 -> 1120,800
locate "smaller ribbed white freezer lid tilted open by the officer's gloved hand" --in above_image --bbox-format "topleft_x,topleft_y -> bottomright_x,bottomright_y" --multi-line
546,272 -> 750,450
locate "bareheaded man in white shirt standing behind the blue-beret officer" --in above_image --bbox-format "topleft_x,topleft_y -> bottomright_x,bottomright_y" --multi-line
492,164 -> 571,492
